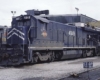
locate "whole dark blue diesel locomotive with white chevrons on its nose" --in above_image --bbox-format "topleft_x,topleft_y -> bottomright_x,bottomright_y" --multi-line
0,10 -> 100,65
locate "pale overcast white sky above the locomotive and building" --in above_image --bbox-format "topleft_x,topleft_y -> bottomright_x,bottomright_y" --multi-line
0,0 -> 100,26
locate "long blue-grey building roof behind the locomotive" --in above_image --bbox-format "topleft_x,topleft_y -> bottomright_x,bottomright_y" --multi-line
40,14 -> 97,24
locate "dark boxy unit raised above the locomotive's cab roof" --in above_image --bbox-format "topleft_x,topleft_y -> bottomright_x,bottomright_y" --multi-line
25,9 -> 49,15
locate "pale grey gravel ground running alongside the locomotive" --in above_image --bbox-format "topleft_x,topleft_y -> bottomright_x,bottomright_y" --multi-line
0,57 -> 100,80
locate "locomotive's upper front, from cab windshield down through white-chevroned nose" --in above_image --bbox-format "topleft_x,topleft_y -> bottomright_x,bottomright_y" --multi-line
7,15 -> 31,44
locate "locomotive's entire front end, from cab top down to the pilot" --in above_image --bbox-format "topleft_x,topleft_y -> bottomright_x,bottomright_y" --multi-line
2,15 -> 35,65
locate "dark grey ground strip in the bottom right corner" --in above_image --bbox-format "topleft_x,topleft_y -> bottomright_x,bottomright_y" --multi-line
60,68 -> 100,80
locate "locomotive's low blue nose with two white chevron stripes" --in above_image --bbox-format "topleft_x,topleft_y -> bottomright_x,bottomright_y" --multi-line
7,27 -> 27,44
